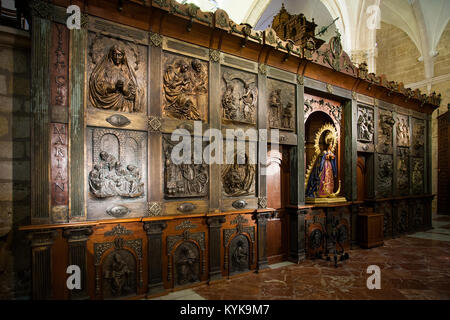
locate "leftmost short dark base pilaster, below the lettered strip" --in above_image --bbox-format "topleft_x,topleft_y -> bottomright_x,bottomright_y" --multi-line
28,230 -> 57,300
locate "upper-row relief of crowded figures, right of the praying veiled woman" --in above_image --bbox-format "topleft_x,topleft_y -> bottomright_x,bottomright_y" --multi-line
162,52 -> 208,121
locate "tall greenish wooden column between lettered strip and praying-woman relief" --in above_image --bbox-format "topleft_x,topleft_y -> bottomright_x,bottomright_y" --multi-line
69,16 -> 88,221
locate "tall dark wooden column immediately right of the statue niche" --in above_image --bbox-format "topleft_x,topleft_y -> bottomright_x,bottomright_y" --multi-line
344,100 -> 358,201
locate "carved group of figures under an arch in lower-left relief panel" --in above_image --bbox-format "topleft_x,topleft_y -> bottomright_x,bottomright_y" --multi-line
89,151 -> 144,198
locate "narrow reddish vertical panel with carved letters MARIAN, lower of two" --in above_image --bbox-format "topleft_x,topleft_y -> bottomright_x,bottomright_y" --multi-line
50,123 -> 69,222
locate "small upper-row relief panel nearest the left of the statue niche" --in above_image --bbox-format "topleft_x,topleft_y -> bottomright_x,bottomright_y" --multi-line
267,79 -> 296,131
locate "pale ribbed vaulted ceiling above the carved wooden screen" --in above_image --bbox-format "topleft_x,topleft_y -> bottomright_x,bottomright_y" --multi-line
178,0 -> 450,87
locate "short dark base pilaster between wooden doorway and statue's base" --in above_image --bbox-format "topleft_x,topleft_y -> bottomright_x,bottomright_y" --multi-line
288,209 -> 306,263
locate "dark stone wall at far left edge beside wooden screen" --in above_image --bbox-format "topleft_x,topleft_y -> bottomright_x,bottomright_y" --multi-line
0,26 -> 31,299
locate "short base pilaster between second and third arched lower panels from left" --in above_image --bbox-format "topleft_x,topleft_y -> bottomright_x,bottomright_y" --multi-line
206,216 -> 225,281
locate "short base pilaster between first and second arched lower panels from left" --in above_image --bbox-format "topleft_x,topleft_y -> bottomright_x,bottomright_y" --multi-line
144,221 -> 167,295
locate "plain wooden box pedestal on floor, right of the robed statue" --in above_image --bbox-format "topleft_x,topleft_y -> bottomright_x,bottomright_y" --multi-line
358,213 -> 384,249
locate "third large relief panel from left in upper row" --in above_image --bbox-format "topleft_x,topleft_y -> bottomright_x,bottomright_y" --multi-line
220,67 -> 258,125
